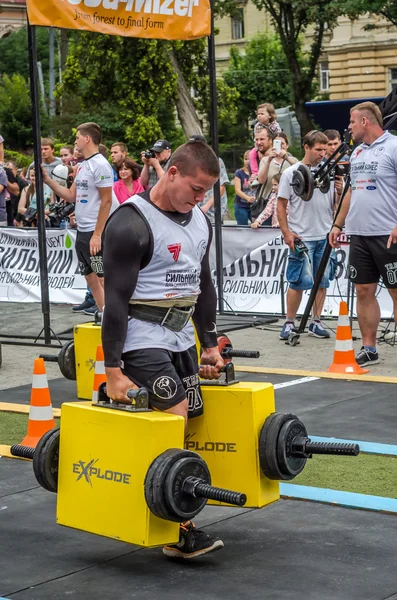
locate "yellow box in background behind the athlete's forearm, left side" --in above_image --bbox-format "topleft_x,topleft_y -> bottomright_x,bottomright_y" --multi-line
74,323 -> 102,400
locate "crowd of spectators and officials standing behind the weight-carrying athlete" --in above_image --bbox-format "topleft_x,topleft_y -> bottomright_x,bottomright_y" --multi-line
0,103 -> 397,366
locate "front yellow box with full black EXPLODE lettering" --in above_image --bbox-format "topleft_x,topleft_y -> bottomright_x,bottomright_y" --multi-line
57,402 -> 184,547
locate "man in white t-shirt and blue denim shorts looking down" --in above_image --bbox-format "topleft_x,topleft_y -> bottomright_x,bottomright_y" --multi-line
277,130 -> 342,340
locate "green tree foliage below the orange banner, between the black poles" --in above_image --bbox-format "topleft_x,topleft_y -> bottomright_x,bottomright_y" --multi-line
58,32 -> 237,149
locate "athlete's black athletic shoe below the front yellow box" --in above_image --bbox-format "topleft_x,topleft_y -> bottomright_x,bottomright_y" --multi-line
163,521 -> 223,558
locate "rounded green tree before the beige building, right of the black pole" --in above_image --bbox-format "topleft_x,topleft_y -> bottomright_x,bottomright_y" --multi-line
223,34 -> 292,122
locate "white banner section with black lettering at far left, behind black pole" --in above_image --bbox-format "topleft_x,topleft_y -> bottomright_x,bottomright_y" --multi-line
0,227 -> 87,304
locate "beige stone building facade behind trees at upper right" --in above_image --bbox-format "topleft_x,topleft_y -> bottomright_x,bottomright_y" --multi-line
215,0 -> 397,100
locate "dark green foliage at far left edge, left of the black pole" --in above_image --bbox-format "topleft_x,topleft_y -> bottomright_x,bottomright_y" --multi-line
0,74 -> 48,150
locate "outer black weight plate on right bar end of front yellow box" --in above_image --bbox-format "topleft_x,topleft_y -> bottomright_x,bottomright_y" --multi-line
164,456 -> 211,523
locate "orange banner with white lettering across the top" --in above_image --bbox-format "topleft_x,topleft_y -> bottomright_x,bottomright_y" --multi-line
27,0 -> 211,40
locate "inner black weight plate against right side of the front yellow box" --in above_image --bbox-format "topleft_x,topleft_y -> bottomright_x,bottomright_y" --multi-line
144,448 -> 199,521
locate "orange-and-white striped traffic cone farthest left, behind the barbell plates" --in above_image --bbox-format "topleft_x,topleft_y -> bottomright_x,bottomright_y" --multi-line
20,358 -> 55,448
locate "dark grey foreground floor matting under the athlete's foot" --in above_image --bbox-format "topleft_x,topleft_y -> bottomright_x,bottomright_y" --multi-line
0,458 -> 397,600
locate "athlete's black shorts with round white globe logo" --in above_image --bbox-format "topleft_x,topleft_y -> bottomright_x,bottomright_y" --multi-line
121,346 -> 203,418
